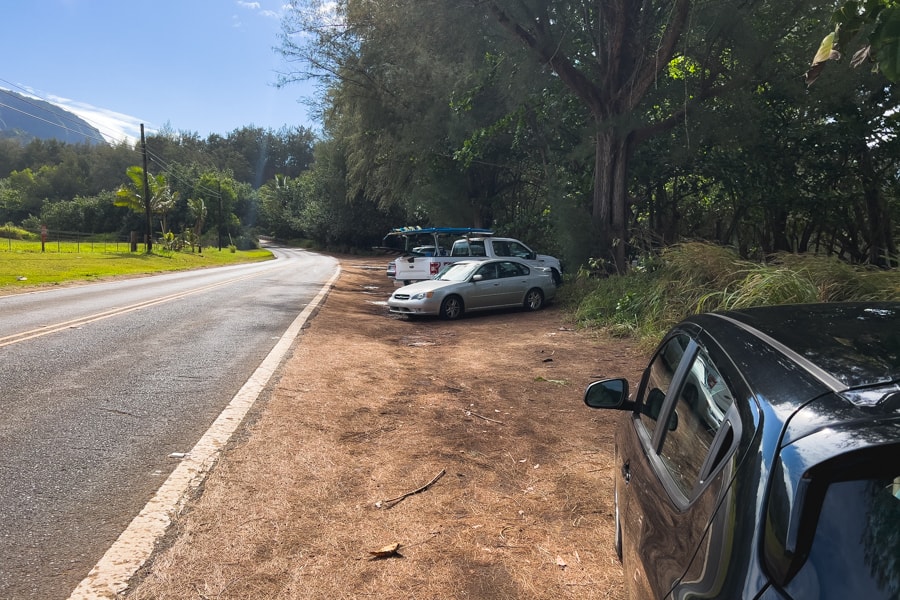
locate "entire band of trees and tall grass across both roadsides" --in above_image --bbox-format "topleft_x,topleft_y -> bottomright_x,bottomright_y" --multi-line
0,0 -> 900,324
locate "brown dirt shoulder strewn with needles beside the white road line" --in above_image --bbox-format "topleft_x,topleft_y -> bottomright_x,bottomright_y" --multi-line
128,258 -> 643,599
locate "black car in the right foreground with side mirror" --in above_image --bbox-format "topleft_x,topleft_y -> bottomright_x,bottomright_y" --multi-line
584,303 -> 900,600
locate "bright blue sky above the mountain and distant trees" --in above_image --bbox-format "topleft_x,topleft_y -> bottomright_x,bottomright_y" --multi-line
0,0 -> 319,140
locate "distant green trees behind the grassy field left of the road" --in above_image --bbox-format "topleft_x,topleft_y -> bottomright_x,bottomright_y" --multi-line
0,127 -> 328,244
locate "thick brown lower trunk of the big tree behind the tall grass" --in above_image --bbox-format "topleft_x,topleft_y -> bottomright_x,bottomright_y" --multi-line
593,130 -> 629,274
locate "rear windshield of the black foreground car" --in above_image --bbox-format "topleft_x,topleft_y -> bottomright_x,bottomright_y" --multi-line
786,474 -> 900,599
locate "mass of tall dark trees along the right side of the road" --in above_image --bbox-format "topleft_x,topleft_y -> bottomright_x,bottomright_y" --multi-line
282,0 -> 897,272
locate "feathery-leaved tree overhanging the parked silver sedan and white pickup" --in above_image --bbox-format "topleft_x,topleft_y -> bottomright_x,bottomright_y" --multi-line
282,0 -> 565,251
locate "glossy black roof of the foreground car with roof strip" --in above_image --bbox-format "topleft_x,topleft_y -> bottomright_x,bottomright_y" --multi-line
687,302 -> 900,412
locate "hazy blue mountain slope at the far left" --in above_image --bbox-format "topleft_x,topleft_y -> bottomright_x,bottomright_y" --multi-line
0,88 -> 104,144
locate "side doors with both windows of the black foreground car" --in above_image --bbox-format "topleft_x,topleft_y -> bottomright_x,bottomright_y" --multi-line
615,331 -> 740,598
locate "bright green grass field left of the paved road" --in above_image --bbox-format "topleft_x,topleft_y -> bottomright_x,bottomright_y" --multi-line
0,239 -> 272,293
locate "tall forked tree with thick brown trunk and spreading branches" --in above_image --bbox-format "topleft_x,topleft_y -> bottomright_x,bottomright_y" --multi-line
472,0 -> 816,271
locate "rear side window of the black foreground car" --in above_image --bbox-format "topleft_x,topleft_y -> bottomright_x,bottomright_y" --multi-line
659,348 -> 734,497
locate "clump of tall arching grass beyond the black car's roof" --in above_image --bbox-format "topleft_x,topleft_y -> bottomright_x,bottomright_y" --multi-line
560,242 -> 900,347
